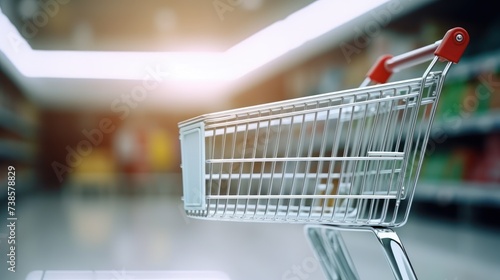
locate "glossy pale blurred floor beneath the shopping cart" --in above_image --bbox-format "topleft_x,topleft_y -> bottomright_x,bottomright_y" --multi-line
0,186 -> 500,280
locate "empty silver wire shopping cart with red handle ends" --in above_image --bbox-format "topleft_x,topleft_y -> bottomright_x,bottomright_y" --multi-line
179,27 -> 469,279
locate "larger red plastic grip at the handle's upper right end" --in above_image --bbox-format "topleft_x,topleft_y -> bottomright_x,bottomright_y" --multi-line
434,27 -> 469,63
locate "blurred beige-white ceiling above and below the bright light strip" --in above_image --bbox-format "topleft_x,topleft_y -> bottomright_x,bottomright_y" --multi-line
0,0 -> 430,112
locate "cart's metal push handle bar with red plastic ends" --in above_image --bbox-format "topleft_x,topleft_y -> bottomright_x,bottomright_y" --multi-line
366,27 -> 469,84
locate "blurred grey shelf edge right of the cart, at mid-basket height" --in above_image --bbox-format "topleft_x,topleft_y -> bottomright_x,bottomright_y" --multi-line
431,110 -> 500,137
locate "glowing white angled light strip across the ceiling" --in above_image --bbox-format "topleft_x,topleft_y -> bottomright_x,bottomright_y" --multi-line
0,0 -> 389,81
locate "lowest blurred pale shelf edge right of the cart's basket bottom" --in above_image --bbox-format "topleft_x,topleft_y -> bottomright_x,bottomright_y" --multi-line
414,181 -> 500,207
